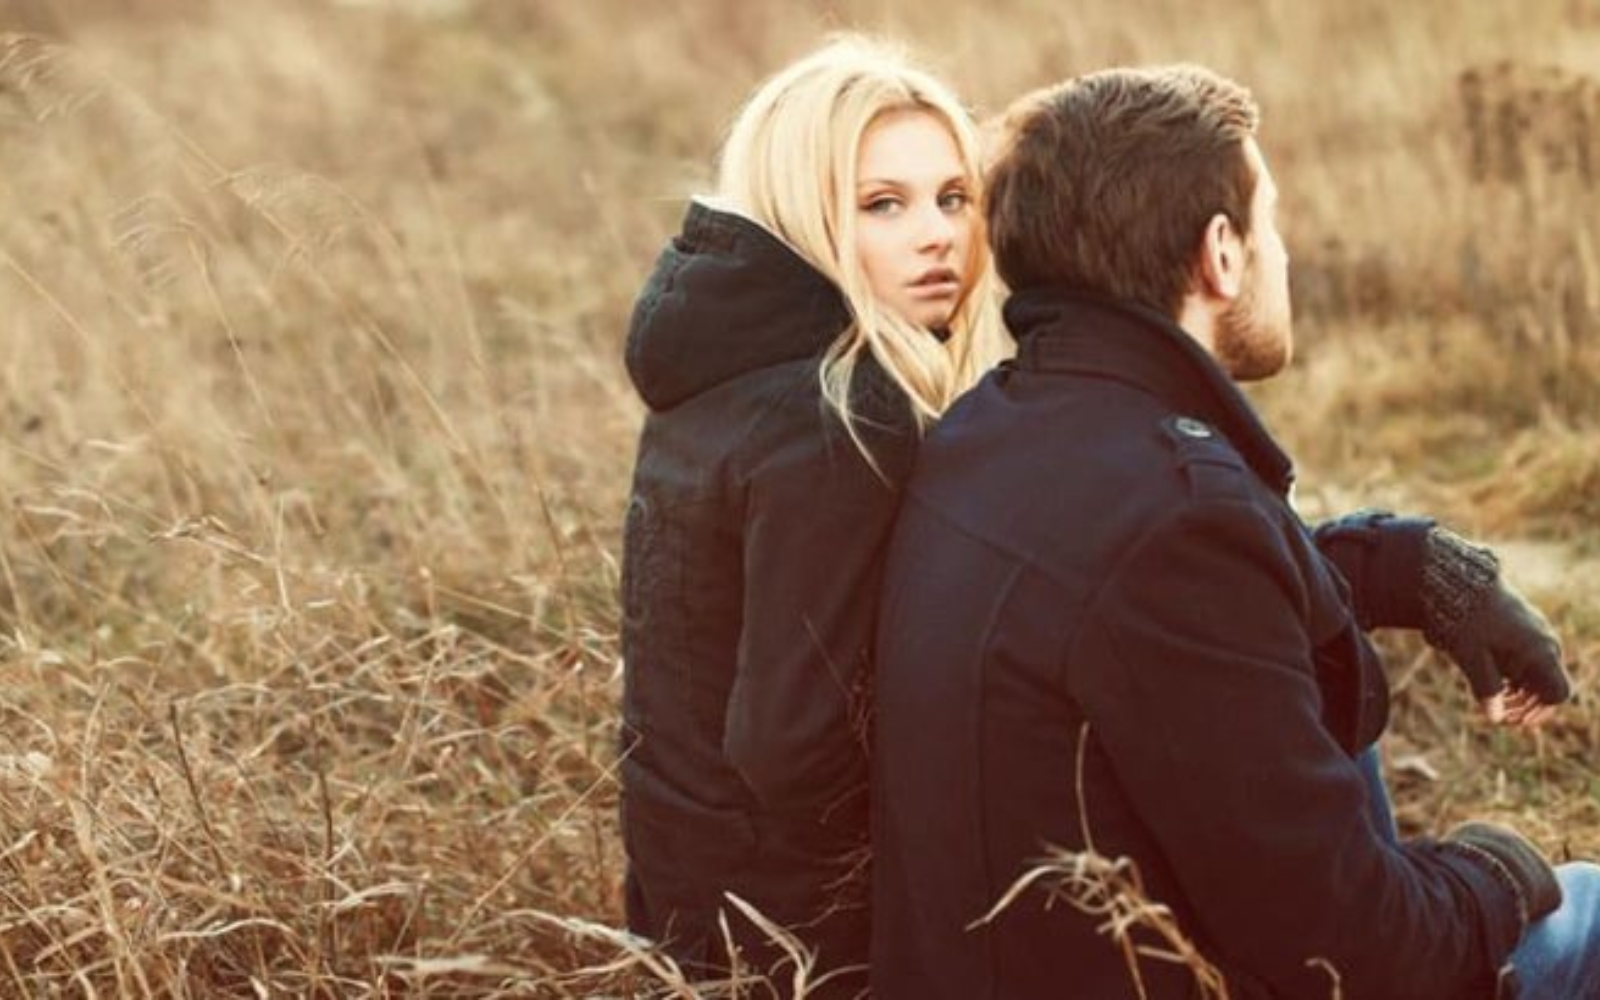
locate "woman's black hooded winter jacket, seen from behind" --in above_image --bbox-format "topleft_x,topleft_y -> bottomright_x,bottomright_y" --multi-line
622,196 -> 918,995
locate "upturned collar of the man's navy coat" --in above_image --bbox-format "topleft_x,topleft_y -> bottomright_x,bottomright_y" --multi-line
1005,288 -> 1294,494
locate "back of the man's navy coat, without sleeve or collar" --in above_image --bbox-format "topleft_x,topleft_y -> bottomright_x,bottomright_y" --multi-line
874,332 -> 1203,998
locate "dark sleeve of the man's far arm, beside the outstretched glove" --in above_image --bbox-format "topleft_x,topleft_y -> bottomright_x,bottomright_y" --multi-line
1314,510 -> 1434,630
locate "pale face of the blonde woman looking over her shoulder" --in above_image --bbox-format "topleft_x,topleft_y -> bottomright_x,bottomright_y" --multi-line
856,110 -> 981,328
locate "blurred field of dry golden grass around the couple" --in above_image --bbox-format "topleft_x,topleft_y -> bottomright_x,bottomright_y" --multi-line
0,0 -> 1600,997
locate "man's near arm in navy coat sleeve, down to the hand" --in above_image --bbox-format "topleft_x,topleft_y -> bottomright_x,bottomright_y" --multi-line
1067,502 -> 1523,1000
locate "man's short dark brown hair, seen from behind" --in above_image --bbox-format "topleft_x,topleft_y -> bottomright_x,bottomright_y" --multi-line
986,66 -> 1259,315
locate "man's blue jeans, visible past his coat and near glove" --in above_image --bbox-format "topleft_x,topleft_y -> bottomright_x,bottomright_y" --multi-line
1355,747 -> 1600,1000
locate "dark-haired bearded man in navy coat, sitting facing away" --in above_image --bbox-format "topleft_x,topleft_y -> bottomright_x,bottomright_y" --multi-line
872,67 -> 1600,1000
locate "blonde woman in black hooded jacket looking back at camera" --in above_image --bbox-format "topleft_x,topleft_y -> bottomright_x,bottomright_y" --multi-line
622,37 -> 1006,997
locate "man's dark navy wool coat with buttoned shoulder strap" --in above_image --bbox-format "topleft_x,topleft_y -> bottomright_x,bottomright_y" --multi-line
872,291 -> 1523,1000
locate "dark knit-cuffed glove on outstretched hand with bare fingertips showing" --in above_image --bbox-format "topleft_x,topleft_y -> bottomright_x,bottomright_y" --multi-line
1422,526 -> 1573,706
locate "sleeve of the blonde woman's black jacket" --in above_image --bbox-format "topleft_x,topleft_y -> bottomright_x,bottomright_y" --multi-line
723,385 -> 915,808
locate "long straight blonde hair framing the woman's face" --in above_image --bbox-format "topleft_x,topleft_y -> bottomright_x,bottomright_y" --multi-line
717,35 -> 1008,462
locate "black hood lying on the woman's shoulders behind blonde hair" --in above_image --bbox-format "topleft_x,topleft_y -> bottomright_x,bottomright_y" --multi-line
626,202 -> 851,410
